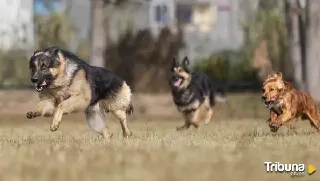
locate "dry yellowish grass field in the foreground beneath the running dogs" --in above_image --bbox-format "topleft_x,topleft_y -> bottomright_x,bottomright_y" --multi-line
0,116 -> 320,181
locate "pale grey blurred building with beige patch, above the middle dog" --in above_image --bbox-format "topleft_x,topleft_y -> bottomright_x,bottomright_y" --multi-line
175,0 -> 243,64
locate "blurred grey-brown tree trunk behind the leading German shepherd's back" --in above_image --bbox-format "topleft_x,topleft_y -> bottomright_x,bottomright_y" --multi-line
90,0 -> 107,67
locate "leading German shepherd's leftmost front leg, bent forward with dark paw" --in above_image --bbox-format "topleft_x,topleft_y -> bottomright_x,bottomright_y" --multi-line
26,99 -> 55,119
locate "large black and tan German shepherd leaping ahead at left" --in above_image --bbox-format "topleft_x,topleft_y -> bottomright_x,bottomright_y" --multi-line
26,47 -> 133,139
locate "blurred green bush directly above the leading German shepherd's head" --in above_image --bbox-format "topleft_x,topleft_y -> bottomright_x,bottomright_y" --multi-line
35,13 -> 75,49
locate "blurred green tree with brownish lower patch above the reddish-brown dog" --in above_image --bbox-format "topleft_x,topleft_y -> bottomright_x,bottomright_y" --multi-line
243,0 -> 292,80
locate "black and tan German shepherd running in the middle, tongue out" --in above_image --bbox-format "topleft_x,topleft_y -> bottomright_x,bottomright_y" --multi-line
169,57 -> 225,130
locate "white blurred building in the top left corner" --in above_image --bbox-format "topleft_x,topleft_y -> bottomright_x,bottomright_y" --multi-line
0,0 -> 34,50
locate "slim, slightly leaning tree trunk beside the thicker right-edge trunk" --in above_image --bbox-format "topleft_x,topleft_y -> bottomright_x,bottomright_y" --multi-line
285,0 -> 305,90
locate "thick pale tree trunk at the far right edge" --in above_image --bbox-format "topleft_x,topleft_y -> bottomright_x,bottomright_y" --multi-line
306,0 -> 320,101
